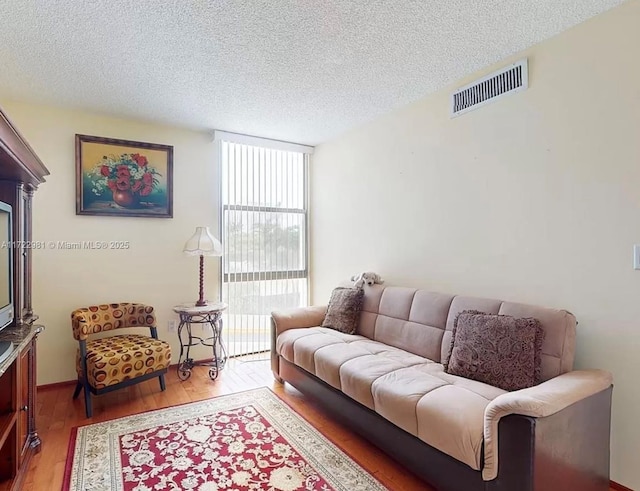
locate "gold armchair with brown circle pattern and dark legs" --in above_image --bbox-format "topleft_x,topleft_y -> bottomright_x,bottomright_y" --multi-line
71,303 -> 171,418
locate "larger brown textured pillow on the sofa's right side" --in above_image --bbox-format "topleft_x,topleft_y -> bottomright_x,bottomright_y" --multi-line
445,310 -> 544,390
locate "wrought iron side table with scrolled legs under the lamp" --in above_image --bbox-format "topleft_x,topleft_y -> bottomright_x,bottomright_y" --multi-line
173,303 -> 227,380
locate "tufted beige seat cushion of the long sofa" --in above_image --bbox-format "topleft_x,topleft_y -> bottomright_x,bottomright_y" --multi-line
276,327 -> 506,470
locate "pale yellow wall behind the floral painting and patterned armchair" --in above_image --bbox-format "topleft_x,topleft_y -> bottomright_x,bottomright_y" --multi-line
0,99 -> 219,384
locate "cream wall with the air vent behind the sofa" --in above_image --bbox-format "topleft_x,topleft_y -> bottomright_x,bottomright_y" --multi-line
311,0 -> 640,489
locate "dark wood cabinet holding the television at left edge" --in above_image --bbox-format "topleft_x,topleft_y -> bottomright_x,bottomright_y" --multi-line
0,105 -> 49,491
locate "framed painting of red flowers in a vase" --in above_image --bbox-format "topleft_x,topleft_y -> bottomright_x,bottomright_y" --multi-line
76,135 -> 173,218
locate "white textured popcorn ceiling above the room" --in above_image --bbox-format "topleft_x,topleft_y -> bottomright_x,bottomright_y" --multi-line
0,0 -> 622,144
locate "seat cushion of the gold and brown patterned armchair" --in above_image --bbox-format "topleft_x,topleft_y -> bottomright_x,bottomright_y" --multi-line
76,334 -> 171,389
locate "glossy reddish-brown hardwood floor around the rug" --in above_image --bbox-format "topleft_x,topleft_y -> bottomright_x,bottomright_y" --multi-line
22,360 -> 616,491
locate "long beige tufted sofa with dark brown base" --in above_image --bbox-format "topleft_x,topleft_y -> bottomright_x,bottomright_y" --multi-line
272,285 -> 612,491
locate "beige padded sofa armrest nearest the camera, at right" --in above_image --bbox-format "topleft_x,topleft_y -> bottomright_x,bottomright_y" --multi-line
482,370 -> 613,481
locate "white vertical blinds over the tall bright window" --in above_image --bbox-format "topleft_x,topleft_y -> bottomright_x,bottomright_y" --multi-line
220,141 -> 308,356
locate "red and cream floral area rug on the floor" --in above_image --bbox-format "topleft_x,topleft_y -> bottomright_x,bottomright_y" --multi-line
62,388 -> 386,491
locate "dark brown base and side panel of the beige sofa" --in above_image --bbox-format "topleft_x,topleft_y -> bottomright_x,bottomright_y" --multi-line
272,355 -> 612,491
